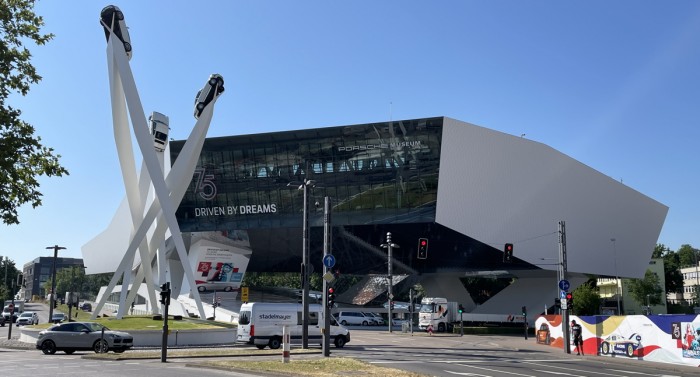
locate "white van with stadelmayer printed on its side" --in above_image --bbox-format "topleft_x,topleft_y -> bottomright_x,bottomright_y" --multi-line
236,302 -> 350,349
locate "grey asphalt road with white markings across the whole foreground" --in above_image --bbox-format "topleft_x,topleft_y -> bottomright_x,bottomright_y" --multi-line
0,327 -> 699,377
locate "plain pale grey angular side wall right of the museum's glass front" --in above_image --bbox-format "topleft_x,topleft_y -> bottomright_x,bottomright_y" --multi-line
436,118 -> 668,277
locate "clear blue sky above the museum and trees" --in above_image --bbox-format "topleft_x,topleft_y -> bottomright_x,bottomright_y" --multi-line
0,0 -> 700,268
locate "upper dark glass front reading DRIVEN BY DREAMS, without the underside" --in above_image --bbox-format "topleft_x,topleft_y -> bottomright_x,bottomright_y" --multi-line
171,118 -> 442,232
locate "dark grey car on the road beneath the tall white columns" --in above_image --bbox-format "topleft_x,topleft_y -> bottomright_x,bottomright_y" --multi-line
36,322 -> 134,355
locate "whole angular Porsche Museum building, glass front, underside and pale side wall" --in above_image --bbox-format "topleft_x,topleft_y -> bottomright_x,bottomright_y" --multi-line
170,117 -> 668,313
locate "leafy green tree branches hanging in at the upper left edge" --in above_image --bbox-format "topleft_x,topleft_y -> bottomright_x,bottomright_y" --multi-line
0,0 -> 68,224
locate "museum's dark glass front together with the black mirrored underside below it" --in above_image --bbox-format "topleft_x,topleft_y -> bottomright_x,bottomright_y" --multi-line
170,118 -> 514,274
